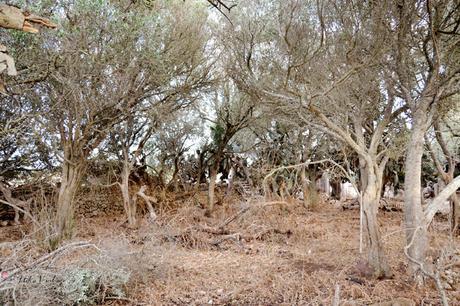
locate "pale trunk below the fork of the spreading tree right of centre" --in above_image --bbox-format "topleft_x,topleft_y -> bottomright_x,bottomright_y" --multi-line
362,165 -> 391,278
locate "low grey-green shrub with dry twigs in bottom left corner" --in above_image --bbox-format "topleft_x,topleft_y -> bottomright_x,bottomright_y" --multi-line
0,255 -> 132,306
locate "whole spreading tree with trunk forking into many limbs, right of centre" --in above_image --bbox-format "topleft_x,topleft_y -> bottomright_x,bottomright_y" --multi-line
223,0 -> 407,276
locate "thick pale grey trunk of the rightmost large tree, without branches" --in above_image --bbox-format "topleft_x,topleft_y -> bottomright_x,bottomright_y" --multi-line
404,111 -> 428,283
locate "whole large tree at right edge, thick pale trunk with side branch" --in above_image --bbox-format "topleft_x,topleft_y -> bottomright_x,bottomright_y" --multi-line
388,0 -> 460,280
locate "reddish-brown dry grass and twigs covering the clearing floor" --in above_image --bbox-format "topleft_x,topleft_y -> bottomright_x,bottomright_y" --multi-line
2,195 -> 460,305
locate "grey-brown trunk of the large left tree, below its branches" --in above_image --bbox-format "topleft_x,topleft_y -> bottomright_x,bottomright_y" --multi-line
56,154 -> 86,239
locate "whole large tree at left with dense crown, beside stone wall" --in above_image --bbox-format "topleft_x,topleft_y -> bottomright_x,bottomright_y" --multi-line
10,0 -> 209,238
